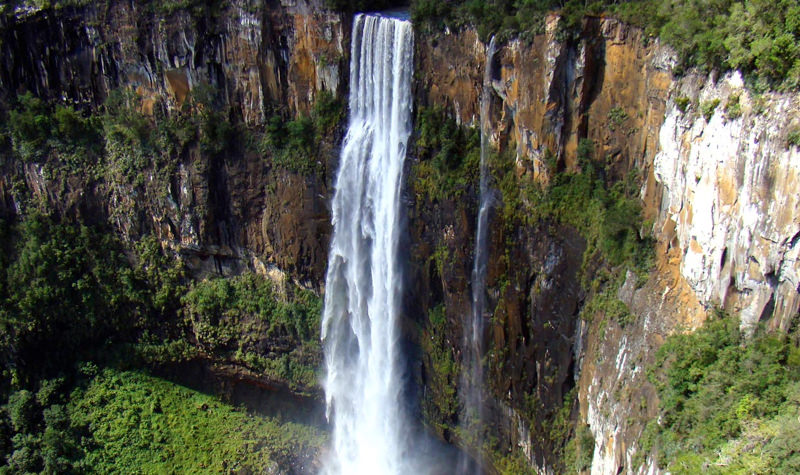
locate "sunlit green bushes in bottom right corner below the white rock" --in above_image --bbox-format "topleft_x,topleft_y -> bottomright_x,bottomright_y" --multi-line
642,313 -> 800,474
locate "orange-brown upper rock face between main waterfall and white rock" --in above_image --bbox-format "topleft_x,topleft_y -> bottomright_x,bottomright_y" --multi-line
418,16 -> 674,181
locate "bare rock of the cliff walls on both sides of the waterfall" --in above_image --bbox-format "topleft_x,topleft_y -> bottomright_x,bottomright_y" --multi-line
0,0 -> 800,473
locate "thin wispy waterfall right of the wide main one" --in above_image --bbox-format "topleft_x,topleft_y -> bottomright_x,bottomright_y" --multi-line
459,36 -> 495,473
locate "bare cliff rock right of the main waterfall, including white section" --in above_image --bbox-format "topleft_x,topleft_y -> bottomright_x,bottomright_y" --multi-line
412,13 -> 800,473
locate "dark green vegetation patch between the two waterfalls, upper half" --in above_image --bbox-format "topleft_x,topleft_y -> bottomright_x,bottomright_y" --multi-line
413,107 -> 480,200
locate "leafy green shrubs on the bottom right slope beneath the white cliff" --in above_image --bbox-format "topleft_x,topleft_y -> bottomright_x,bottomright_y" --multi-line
644,313 -> 800,471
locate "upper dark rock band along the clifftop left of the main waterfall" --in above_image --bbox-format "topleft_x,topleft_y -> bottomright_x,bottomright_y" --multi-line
0,0 -> 349,124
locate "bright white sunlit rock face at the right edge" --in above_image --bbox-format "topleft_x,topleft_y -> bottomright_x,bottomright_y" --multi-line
654,74 -> 800,330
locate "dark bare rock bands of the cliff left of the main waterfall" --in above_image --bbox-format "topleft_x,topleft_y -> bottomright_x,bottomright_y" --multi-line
0,1 -> 340,288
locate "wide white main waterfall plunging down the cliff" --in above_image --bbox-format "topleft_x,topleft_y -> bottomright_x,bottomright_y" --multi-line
322,14 -> 414,474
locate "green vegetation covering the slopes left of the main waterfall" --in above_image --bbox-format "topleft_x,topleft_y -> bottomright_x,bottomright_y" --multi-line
0,82 -> 332,473
